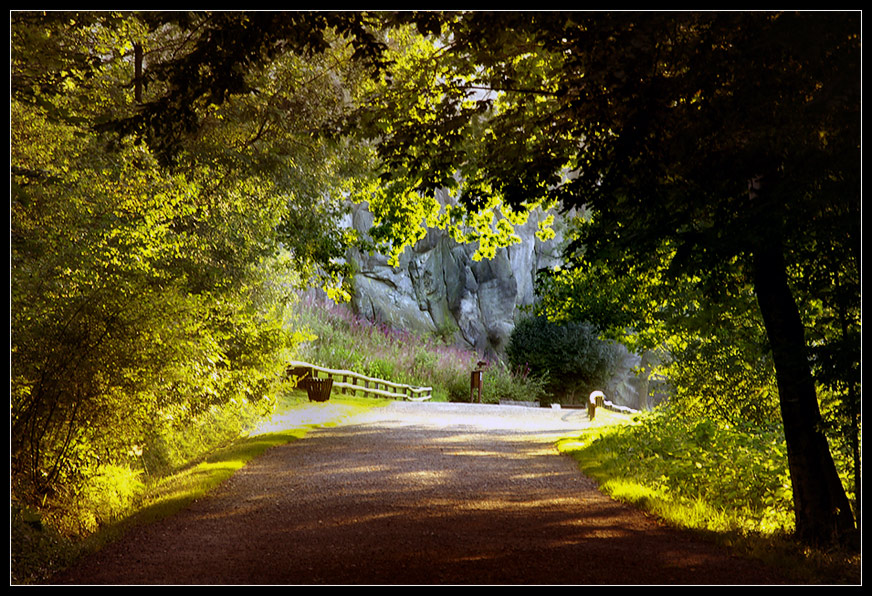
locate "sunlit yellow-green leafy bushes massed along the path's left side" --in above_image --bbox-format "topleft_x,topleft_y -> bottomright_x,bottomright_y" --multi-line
12,112 -> 289,508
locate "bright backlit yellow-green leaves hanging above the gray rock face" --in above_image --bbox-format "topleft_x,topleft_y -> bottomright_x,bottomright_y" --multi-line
344,22 -> 550,263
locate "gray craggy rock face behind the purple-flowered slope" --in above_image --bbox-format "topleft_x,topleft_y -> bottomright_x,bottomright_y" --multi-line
349,197 -> 562,357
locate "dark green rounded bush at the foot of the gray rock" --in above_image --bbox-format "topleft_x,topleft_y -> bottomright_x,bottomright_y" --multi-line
506,316 -> 620,399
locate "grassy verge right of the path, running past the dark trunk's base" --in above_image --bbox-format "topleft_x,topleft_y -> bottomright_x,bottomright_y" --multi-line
558,411 -> 861,584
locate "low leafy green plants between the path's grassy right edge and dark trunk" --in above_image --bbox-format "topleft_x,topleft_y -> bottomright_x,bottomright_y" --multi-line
562,408 -> 793,535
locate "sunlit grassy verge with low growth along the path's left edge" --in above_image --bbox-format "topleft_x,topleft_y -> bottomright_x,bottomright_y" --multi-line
10,387 -> 378,585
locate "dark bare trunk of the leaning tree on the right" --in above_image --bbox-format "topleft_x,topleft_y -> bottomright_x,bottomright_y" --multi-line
752,178 -> 854,545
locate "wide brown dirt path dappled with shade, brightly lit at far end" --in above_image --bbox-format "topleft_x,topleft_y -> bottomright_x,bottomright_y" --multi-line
51,403 -> 779,585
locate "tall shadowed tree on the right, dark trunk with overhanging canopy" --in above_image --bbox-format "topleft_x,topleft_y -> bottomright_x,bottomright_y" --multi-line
354,12 -> 860,542
